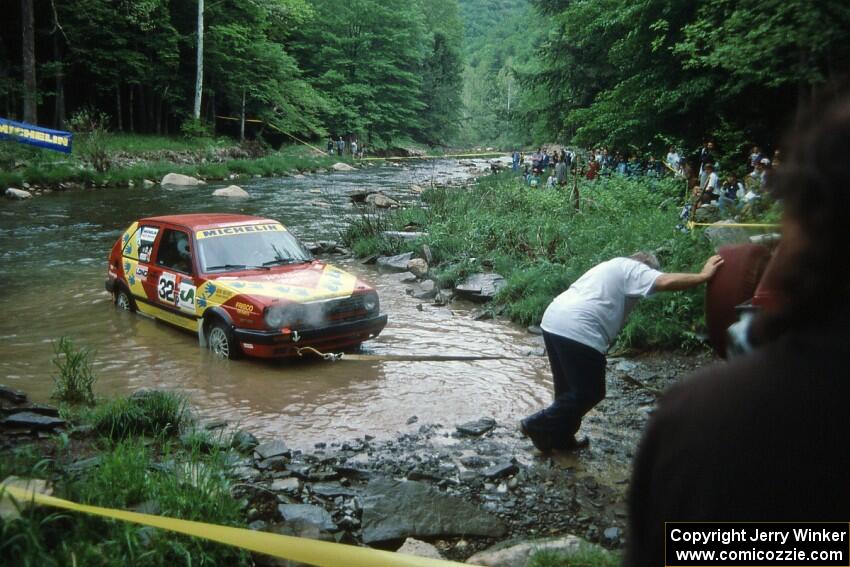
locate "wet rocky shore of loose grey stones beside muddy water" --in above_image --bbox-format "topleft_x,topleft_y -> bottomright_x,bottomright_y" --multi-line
0,354 -> 710,560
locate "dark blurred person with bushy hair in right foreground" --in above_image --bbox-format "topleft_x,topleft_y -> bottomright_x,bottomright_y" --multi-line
625,97 -> 850,566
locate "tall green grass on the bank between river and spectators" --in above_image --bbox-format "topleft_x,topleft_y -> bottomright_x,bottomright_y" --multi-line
343,173 -> 711,349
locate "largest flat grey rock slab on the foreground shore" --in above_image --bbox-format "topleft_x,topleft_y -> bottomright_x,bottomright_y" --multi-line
362,479 -> 506,545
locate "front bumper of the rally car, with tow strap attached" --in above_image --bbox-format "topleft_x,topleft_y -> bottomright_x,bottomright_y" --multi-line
233,315 -> 387,358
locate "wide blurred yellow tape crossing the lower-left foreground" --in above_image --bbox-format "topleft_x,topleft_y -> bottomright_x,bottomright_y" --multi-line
0,484 -> 464,567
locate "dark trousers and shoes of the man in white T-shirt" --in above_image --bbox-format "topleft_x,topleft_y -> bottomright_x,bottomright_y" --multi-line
527,331 -> 605,447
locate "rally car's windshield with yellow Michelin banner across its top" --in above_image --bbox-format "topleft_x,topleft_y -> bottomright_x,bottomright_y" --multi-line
197,225 -> 312,272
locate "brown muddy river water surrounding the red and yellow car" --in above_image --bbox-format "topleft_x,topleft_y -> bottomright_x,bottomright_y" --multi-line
0,161 -> 551,448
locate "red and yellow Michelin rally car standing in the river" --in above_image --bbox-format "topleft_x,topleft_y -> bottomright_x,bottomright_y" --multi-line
106,214 -> 387,358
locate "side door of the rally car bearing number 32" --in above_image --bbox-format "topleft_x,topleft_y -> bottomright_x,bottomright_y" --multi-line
148,226 -> 197,330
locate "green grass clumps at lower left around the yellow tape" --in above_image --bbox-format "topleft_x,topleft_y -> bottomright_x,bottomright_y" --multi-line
0,391 -> 250,566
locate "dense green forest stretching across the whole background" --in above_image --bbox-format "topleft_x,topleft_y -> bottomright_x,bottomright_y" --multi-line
0,0 -> 850,151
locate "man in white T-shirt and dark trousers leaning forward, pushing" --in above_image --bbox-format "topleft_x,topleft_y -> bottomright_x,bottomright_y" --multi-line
520,252 -> 723,453
